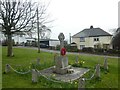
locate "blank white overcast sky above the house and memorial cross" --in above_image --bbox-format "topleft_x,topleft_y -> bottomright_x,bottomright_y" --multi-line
37,0 -> 119,40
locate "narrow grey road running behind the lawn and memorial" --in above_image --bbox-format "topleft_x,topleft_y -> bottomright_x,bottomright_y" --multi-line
16,46 -> 120,58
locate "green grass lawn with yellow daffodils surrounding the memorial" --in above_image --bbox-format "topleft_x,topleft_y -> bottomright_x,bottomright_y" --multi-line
2,47 -> 118,88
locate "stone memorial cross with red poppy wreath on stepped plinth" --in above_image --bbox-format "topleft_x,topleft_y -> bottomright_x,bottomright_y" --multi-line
53,33 -> 73,74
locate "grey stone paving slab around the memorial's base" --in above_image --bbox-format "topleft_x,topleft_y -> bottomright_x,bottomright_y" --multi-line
40,67 -> 89,82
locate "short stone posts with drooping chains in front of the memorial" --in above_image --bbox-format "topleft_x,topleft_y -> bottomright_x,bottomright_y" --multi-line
5,57 -> 108,88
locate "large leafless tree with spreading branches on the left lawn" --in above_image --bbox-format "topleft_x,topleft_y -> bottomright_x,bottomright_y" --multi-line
0,0 -> 49,56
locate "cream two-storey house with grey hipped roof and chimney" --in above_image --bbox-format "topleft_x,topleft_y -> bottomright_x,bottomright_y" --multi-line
72,26 -> 112,49
